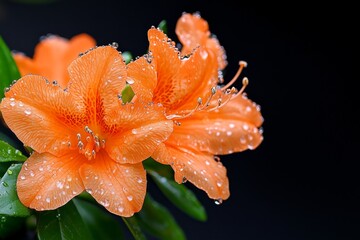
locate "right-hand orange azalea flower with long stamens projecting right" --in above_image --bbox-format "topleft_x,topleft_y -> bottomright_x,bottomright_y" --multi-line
128,20 -> 263,201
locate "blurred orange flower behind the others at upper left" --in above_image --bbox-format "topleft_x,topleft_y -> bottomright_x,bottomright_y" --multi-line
14,33 -> 96,87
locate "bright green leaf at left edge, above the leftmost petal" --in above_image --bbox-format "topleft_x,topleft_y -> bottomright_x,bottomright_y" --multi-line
0,36 -> 20,99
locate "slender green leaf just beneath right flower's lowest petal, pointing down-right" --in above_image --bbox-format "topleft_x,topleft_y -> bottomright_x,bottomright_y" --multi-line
147,170 -> 207,221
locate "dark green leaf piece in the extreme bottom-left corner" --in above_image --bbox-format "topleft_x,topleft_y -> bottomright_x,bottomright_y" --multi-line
0,215 -> 26,239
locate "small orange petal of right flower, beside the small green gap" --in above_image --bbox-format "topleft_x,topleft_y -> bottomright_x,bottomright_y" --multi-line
127,57 -> 157,102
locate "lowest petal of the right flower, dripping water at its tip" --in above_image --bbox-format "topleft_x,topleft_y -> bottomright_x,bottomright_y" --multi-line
152,144 -> 230,200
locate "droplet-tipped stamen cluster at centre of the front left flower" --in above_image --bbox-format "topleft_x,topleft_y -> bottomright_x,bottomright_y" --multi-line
76,126 -> 105,160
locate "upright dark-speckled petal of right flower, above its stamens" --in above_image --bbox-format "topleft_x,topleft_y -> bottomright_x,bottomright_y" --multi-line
148,29 -> 217,110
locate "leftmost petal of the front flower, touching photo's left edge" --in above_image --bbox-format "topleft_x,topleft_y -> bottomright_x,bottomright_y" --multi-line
0,75 -> 84,156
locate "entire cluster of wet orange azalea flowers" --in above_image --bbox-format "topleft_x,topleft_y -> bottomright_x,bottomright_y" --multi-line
1,13 -> 263,216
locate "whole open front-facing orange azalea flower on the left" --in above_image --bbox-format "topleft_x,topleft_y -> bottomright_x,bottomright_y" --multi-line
1,46 -> 173,216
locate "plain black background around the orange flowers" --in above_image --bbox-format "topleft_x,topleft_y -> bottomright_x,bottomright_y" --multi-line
0,0 -> 360,240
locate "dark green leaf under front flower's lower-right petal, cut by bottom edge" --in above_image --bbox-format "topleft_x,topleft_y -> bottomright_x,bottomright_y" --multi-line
73,199 -> 124,240
